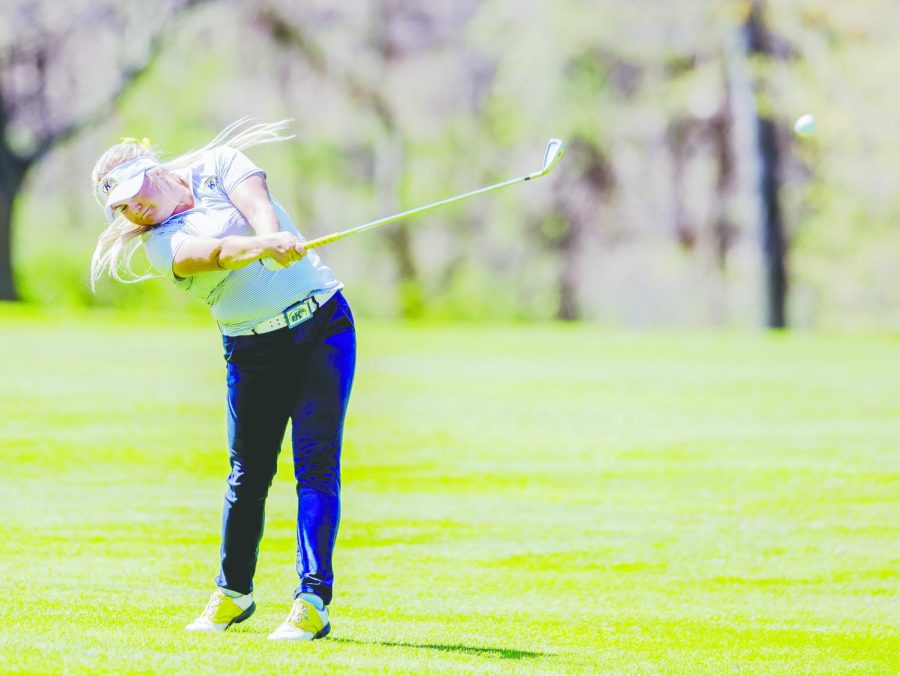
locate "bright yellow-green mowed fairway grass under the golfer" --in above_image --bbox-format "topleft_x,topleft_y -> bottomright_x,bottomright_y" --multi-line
0,307 -> 900,674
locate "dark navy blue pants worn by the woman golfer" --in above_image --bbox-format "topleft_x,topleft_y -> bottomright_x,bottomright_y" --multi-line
216,293 -> 356,604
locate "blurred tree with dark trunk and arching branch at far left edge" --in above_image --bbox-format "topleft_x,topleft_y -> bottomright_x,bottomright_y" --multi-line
0,0 -> 208,300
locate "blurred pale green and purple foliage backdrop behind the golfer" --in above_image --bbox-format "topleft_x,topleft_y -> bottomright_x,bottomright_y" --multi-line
0,0 -> 900,329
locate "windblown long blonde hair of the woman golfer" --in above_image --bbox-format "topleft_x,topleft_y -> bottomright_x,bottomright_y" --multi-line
91,117 -> 294,291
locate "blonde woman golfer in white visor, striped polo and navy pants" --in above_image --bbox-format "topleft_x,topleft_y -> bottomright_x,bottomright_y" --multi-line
91,121 -> 356,640
